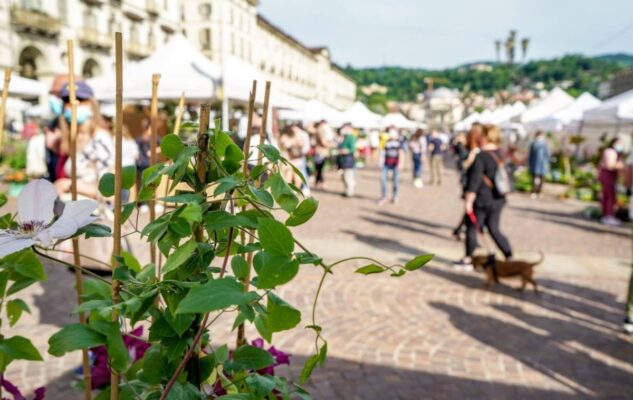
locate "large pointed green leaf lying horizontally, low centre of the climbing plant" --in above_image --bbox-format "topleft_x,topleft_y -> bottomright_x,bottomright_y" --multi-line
176,277 -> 257,314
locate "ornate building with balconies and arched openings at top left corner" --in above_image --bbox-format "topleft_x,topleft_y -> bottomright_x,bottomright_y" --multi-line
0,0 -> 181,90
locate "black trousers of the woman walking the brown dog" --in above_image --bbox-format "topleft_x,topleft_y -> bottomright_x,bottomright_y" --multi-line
466,199 -> 512,258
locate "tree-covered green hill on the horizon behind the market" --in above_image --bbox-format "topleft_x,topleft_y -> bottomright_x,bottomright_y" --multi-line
344,54 -> 633,102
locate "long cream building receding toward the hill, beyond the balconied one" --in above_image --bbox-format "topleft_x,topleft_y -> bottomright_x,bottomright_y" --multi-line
182,0 -> 356,110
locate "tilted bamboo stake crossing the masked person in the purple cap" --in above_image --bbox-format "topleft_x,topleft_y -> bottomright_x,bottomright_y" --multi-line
67,40 -> 92,400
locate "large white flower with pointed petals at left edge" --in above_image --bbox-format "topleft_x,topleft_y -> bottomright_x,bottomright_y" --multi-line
0,179 -> 98,258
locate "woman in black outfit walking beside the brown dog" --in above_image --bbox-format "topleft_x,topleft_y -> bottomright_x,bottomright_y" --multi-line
456,125 -> 512,270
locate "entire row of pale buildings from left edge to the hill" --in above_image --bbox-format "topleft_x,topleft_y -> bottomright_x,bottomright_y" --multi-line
0,0 -> 356,109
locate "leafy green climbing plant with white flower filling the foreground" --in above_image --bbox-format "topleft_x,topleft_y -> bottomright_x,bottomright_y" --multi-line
0,110 -> 432,400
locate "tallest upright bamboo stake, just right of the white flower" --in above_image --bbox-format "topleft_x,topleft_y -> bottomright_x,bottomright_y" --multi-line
110,32 -> 123,400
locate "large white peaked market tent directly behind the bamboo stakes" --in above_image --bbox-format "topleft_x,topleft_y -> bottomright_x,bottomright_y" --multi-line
87,35 -> 221,101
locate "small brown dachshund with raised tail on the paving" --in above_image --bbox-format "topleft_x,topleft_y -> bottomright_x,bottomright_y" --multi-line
473,252 -> 545,293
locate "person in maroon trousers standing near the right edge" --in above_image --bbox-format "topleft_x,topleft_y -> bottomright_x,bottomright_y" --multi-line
598,138 -> 624,226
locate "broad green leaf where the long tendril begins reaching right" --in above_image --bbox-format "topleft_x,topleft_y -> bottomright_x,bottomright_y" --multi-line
253,251 -> 299,289
